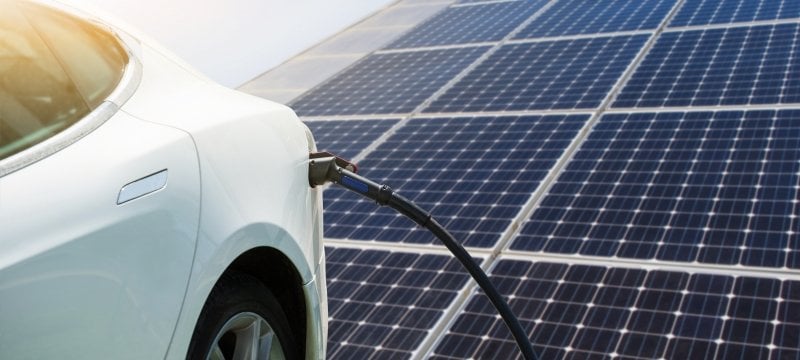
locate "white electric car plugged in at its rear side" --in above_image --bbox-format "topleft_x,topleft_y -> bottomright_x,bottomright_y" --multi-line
0,0 -> 327,359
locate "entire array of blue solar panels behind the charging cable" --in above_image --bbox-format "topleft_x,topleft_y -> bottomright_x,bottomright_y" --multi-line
291,0 -> 800,359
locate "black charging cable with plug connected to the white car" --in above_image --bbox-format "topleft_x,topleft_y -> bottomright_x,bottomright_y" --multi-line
308,152 -> 538,360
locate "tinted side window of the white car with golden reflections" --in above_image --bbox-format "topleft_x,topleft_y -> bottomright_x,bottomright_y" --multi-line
0,0 -> 128,160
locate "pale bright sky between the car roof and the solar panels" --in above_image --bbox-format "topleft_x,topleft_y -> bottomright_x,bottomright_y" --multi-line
64,0 -> 392,87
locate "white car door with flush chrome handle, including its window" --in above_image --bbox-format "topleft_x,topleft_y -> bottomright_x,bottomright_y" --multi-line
0,3 -> 200,359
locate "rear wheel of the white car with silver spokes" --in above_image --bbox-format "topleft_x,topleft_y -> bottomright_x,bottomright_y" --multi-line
186,273 -> 298,360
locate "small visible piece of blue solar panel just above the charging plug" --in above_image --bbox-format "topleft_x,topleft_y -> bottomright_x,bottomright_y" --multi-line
305,119 -> 398,159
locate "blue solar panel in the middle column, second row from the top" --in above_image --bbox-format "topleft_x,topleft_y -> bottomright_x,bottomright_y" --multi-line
424,35 -> 648,112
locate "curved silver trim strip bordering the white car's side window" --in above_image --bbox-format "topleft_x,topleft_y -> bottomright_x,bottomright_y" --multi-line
0,35 -> 142,178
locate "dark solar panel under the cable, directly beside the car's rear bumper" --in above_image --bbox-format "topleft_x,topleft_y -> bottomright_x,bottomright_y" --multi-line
326,248 -> 476,359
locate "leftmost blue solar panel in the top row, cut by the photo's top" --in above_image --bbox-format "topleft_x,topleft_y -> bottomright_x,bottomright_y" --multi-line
387,0 -> 547,49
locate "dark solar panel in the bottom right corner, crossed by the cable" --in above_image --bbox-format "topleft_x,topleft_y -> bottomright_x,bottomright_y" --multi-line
431,260 -> 800,359
